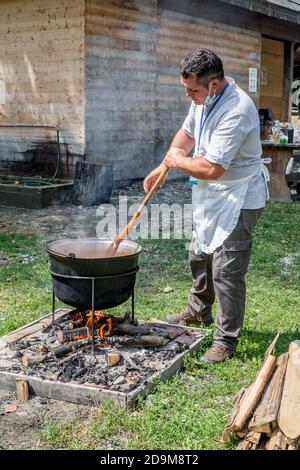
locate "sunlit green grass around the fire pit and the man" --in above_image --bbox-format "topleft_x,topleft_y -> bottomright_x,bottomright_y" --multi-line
0,203 -> 300,450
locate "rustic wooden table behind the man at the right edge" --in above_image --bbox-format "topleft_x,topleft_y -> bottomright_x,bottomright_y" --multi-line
262,142 -> 300,201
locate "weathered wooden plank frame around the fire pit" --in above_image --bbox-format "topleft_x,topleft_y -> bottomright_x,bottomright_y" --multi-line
0,308 -> 207,409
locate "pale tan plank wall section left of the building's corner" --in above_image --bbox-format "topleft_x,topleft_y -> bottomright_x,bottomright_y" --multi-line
0,0 -> 85,174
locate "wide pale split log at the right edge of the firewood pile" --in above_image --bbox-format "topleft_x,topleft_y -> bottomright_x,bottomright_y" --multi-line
278,341 -> 300,440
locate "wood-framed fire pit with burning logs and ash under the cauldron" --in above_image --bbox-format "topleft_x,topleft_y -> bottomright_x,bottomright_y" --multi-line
0,309 -> 205,406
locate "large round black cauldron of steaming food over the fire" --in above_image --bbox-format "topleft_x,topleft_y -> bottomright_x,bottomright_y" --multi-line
46,238 -> 142,310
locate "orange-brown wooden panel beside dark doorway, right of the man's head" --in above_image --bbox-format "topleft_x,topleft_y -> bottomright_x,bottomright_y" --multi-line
259,38 -> 284,120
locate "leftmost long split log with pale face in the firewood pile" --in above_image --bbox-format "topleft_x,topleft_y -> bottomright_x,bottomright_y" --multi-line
230,356 -> 276,431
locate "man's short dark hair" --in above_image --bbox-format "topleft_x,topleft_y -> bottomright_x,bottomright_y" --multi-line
180,49 -> 224,86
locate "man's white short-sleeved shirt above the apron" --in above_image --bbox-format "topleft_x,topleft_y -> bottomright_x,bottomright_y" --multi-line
182,77 -> 267,209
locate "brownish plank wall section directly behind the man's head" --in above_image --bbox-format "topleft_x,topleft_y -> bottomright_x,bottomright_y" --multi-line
156,7 -> 261,158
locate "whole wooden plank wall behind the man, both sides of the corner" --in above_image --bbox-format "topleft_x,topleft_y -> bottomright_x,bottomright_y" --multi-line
0,0 -> 261,182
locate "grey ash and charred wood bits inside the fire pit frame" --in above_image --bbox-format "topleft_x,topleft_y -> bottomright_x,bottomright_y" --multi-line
0,312 -> 199,392
